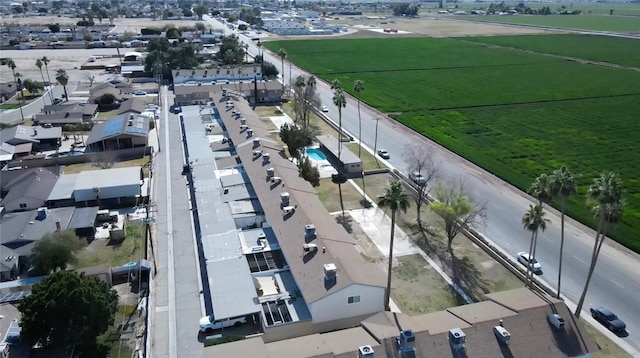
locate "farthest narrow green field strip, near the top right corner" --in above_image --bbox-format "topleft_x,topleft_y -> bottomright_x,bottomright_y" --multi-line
455,15 -> 640,32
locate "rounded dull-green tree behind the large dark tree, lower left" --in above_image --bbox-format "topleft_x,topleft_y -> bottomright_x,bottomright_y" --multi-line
30,230 -> 83,275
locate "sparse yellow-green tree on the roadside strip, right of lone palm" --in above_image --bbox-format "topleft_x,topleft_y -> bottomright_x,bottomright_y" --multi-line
431,181 -> 486,255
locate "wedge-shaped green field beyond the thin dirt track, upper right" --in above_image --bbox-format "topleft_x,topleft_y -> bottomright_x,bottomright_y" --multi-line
465,34 -> 640,68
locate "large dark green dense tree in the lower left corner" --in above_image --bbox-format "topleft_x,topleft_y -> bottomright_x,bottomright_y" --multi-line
18,271 -> 118,357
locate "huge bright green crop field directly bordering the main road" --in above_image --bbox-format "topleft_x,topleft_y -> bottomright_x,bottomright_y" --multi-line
265,36 -> 640,252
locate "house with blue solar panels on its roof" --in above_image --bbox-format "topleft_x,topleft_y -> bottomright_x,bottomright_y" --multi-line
85,115 -> 150,152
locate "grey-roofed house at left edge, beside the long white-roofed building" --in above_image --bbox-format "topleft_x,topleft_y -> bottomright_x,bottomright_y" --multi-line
0,167 -> 60,212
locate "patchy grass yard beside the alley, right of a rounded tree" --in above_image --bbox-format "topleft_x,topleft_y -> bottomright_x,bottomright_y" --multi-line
74,221 -> 145,268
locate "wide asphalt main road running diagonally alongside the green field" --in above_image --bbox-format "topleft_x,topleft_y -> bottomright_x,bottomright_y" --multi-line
207,19 -> 640,355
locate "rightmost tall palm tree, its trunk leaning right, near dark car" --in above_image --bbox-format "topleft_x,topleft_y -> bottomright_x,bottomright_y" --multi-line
575,172 -> 624,318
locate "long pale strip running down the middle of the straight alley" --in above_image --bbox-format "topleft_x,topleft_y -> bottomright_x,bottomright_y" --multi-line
161,87 -> 178,357
